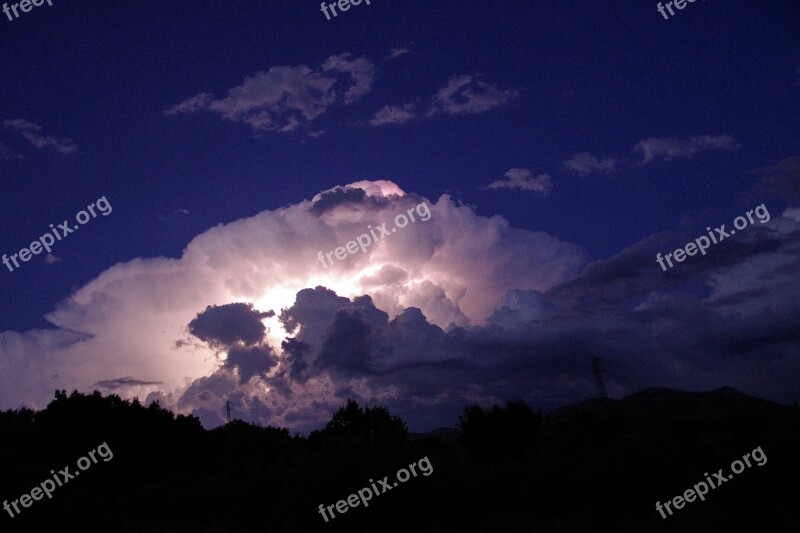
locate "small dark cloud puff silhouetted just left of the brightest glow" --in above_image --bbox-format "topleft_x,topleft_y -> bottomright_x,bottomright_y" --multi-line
189,303 -> 275,347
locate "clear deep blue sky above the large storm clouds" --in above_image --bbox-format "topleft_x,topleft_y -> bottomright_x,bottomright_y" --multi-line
0,0 -> 800,430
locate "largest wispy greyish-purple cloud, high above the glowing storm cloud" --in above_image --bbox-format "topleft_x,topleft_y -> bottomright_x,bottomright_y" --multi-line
164,54 -> 376,133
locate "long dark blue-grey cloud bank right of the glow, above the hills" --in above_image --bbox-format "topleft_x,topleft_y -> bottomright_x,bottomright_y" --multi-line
238,210 -> 800,428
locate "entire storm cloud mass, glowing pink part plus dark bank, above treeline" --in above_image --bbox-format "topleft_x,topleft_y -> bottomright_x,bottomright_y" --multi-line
0,181 -> 800,431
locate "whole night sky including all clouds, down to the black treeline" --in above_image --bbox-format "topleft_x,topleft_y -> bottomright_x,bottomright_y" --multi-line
0,0 -> 800,432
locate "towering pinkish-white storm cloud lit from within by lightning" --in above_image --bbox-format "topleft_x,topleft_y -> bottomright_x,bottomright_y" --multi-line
0,181 -> 585,423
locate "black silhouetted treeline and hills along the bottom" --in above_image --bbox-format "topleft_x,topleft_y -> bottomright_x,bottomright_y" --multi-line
0,388 -> 800,533
